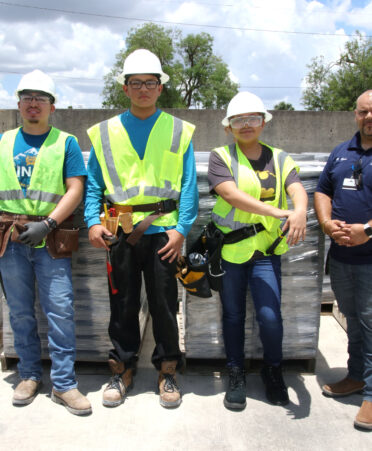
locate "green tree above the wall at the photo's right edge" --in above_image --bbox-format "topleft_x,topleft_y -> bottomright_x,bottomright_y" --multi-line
302,31 -> 372,111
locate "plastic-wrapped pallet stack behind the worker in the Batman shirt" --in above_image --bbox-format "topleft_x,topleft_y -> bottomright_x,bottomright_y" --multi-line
183,153 -> 327,359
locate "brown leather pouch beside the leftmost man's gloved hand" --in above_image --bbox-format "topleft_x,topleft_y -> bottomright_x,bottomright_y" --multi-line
46,228 -> 79,258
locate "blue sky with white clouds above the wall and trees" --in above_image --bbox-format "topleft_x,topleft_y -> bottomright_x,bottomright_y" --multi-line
0,0 -> 372,109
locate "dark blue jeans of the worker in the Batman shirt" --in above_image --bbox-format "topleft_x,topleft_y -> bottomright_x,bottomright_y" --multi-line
220,255 -> 283,368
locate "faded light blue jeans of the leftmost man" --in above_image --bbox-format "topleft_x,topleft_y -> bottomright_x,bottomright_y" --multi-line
0,241 -> 77,391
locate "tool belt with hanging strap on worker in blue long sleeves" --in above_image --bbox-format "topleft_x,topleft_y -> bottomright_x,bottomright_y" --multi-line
113,199 -> 177,246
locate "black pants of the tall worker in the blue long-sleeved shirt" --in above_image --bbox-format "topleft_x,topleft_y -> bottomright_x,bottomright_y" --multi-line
109,230 -> 181,369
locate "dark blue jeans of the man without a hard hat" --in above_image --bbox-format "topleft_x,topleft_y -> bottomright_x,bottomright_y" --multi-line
329,258 -> 372,401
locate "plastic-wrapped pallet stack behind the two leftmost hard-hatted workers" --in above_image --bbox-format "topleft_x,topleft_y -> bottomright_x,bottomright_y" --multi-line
0,153 -> 148,362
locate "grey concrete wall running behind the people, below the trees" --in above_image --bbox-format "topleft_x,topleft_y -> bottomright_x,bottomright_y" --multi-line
0,109 -> 356,153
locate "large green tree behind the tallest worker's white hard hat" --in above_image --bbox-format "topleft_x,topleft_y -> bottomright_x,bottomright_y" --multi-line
102,23 -> 238,108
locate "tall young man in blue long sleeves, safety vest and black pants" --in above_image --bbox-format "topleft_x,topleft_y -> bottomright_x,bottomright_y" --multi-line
85,49 -> 198,407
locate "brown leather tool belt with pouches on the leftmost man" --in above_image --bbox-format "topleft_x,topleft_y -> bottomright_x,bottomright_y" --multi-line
0,211 -> 79,258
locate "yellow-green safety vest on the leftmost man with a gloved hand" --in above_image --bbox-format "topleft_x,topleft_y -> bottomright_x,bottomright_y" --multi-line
0,127 -> 71,216
